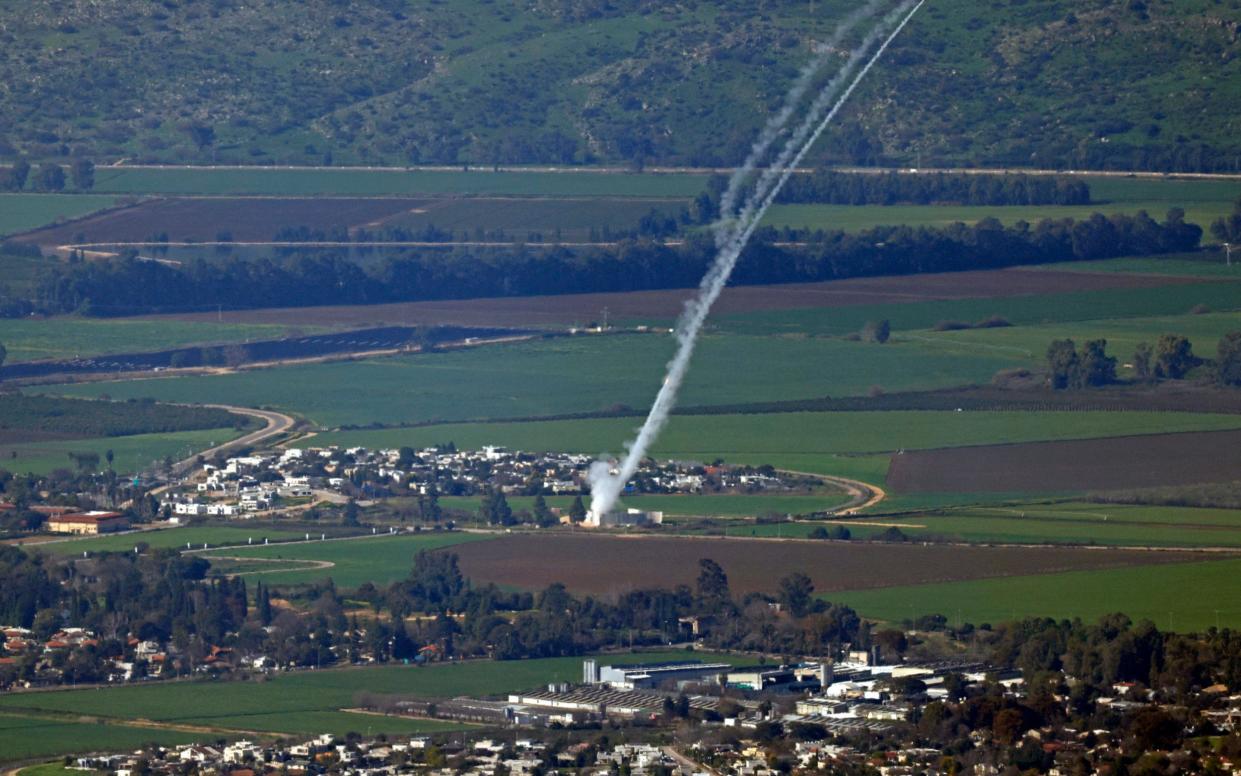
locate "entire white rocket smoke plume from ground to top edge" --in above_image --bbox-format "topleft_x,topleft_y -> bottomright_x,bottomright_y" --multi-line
589,0 -> 926,520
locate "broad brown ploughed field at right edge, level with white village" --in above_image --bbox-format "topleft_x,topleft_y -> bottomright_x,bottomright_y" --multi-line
887,427 -> 1241,493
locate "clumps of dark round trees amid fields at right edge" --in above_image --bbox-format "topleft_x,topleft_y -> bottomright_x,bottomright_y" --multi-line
1047,332 -> 1241,390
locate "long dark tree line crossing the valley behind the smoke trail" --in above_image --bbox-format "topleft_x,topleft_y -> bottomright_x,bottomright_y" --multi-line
19,209 -> 1203,315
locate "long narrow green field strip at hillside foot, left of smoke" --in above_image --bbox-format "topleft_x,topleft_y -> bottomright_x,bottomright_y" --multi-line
94,168 -> 706,197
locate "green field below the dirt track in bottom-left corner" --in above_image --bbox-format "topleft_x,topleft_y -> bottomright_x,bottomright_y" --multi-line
0,714 -> 196,759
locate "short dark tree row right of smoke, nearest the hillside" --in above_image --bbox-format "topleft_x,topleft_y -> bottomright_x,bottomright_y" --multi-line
777,169 -> 1091,205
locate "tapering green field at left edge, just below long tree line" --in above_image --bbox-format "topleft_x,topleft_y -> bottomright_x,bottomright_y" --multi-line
0,317 -> 320,364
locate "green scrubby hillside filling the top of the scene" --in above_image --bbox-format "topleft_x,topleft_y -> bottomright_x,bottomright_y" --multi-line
0,0 -> 1241,169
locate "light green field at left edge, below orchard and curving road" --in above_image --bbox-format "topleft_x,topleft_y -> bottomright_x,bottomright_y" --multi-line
0,428 -> 240,474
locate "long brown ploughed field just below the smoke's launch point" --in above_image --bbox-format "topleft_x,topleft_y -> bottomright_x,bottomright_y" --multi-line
452,534 -> 1193,595
